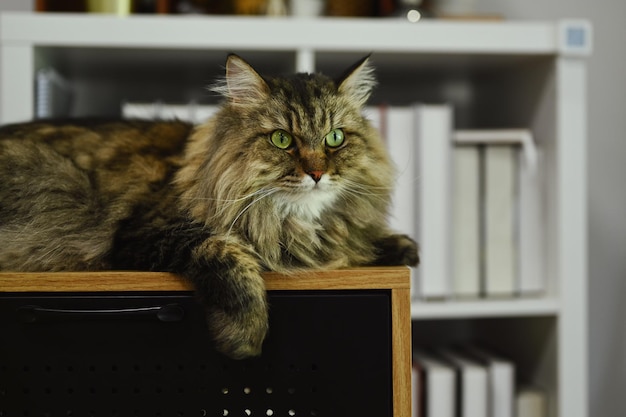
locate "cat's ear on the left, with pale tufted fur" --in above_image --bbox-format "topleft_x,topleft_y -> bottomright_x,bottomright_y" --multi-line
212,54 -> 269,105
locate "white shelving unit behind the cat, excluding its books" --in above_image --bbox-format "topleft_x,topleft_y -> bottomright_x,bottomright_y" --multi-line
0,13 -> 591,417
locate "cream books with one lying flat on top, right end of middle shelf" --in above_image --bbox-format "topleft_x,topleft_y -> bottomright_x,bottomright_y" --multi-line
451,129 -> 543,297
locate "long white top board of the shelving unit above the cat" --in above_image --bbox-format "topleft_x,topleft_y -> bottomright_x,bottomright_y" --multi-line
0,13 -> 559,54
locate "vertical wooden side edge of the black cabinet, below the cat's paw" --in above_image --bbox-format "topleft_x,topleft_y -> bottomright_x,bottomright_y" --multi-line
391,289 -> 412,417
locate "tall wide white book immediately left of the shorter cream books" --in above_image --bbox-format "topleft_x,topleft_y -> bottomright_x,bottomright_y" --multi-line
414,104 -> 453,299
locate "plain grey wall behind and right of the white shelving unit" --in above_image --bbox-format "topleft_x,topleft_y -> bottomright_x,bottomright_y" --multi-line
0,0 -> 626,417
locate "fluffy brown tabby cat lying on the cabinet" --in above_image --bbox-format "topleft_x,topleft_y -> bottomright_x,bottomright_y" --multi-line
0,55 -> 418,358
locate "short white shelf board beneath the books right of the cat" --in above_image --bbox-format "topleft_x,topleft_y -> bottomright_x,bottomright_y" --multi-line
411,298 -> 560,320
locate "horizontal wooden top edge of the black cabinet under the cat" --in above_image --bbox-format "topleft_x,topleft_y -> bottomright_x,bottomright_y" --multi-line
0,267 -> 410,293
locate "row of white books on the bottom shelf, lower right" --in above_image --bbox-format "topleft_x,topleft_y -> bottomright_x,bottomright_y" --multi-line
412,347 -> 547,417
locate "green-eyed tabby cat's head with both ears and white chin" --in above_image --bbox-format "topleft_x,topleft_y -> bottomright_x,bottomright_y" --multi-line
193,56 -> 393,226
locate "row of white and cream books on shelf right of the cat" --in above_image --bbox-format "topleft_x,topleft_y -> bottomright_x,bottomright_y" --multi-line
368,104 -> 544,299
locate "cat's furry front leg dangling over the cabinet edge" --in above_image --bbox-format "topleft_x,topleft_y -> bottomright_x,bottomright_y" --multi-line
111,219 -> 268,359
